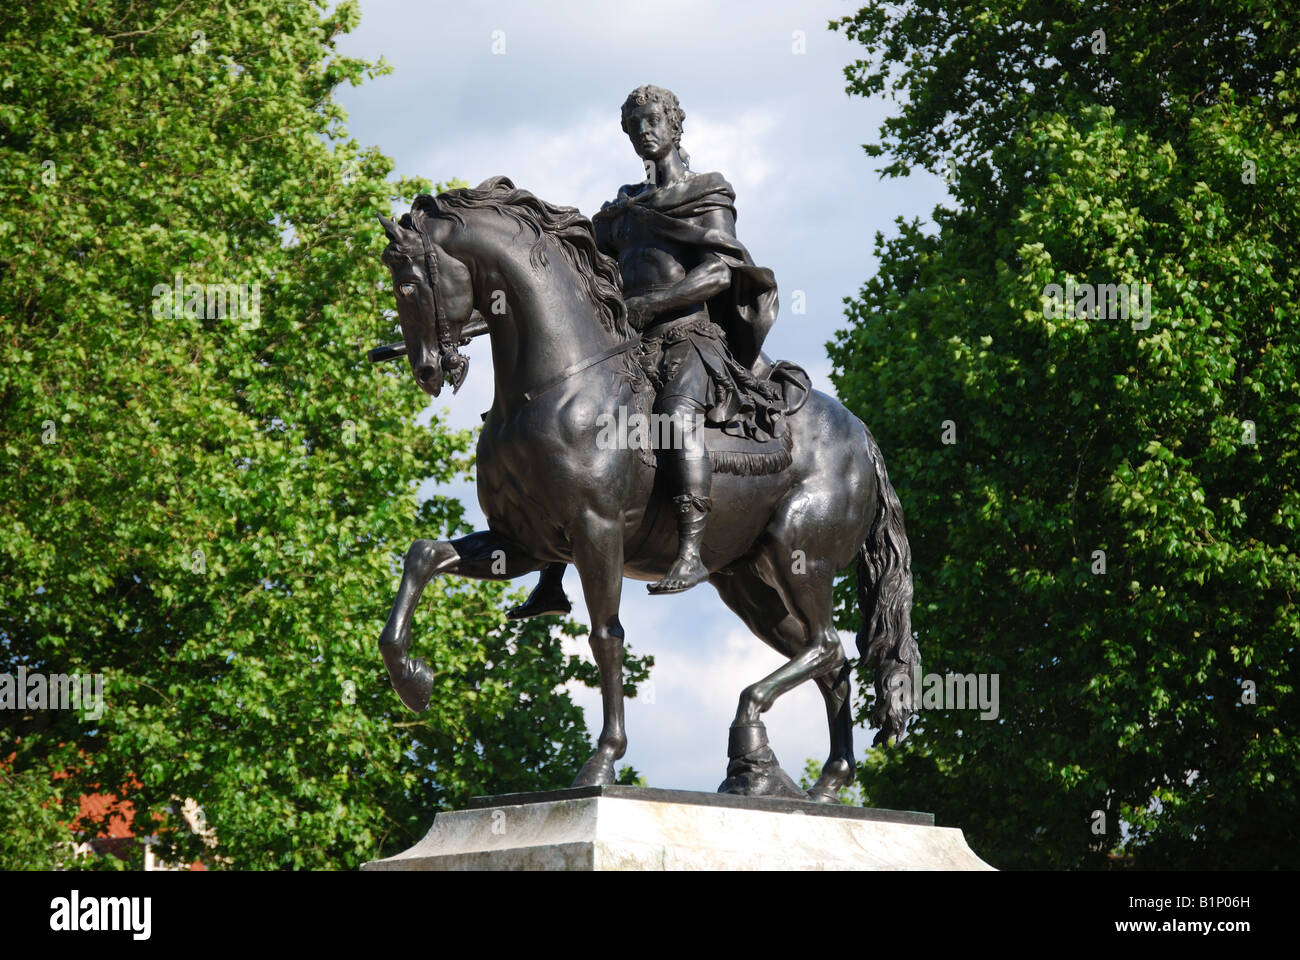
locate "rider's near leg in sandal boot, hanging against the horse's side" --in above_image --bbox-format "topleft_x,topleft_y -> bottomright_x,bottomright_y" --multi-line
647,395 -> 714,593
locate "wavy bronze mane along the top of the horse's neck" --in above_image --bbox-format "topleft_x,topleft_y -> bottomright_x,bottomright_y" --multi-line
403,177 -> 636,340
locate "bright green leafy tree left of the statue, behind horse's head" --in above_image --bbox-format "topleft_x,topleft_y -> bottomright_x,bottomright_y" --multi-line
0,0 -> 646,869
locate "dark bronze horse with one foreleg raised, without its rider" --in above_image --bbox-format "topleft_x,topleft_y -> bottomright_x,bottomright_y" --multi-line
371,177 -> 919,803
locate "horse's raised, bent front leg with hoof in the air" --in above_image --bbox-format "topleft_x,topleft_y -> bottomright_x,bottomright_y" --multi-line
380,531 -> 542,713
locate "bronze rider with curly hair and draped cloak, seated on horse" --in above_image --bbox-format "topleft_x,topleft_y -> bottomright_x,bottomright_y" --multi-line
510,86 -> 784,618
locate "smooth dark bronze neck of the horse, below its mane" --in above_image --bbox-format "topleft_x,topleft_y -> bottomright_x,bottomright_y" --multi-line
480,254 -> 620,412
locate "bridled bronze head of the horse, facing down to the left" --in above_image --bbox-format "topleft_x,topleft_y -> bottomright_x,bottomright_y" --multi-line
372,212 -> 475,397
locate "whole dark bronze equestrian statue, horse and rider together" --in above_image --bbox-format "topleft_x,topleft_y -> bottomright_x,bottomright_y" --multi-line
372,87 -> 919,801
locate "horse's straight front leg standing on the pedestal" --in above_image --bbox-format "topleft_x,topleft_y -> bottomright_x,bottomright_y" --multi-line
573,518 -> 628,787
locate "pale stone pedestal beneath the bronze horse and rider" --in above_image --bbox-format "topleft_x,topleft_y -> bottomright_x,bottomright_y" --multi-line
361,786 -> 993,870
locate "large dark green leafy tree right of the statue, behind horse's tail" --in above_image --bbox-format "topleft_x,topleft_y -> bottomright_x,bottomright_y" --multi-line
831,0 -> 1300,868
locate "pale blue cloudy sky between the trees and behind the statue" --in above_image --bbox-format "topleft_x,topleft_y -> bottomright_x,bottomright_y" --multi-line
338,0 -> 946,791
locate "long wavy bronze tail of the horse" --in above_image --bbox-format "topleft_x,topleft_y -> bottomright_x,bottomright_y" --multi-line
858,431 -> 920,745
